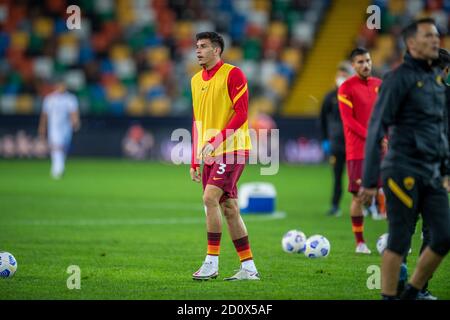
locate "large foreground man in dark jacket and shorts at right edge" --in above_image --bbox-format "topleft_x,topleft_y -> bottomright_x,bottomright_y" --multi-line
360,19 -> 450,299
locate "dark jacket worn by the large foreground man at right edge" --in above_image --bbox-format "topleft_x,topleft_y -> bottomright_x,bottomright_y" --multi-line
362,53 -> 450,188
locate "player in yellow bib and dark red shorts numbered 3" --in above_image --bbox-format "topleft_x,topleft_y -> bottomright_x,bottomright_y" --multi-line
190,32 -> 259,280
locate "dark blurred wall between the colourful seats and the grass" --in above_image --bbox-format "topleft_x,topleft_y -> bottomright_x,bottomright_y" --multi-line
0,115 -> 323,163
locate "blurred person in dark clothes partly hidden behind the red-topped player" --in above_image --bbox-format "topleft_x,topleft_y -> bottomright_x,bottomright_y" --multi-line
320,62 -> 352,217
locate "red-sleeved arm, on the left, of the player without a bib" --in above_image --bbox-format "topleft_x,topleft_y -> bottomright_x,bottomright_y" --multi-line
338,81 -> 367,140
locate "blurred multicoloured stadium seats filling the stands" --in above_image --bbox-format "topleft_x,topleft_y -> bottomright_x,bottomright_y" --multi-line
0,0 -> 422,116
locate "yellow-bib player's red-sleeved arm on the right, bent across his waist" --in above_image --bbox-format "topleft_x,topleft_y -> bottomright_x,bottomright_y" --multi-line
205,68 -> 248,152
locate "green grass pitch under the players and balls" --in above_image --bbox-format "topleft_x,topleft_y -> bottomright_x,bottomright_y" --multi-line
0,159 -> 450,300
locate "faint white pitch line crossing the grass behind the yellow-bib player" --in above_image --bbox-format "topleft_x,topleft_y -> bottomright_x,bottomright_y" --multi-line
2,211 -> 286,226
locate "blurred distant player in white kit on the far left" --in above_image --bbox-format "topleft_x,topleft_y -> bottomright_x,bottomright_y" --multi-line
38,81 -> 80,179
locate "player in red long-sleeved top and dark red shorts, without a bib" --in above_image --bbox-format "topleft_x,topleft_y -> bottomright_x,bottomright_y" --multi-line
338,48 -> 381,254
